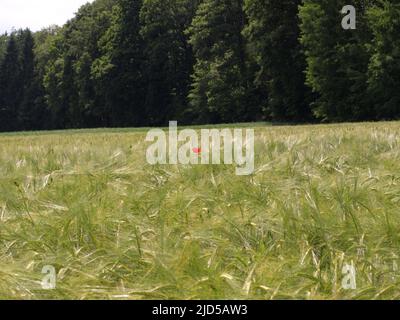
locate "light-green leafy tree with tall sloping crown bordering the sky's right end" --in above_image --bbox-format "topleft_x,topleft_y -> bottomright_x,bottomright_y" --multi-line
43,0 -> 115,128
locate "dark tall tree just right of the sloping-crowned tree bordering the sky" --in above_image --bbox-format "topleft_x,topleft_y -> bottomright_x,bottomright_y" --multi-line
92,0 -> 147,127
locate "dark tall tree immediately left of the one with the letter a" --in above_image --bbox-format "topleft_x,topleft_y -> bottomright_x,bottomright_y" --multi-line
245,0 -> 311,121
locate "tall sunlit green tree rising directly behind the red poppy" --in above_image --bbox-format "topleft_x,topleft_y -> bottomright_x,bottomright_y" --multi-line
188,0 -> 251,122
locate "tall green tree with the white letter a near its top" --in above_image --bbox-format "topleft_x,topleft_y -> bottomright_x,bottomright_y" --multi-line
300,0 -> 373,121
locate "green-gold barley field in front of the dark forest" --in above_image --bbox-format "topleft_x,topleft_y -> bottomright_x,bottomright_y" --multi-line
0,122 -> 400,299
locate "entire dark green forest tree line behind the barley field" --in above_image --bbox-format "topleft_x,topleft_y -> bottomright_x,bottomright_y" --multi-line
0,0 -> 400,131
